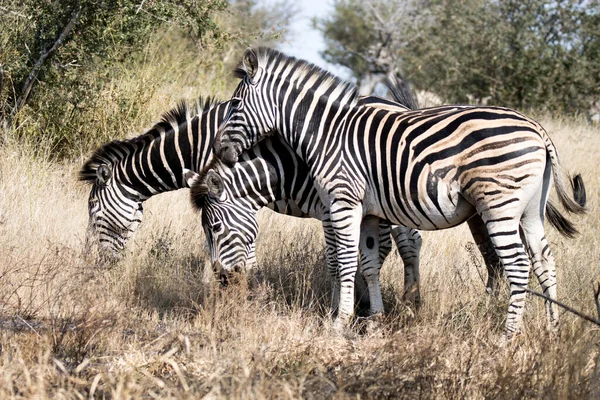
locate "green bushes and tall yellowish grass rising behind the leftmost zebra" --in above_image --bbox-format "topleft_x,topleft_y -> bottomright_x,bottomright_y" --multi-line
0,0 -> 289,157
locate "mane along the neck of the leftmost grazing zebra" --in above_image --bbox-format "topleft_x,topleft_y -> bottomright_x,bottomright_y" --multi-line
79,96 -> 220,182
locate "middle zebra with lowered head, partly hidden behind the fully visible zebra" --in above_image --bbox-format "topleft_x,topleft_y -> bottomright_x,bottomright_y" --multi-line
188,80 -> 510,314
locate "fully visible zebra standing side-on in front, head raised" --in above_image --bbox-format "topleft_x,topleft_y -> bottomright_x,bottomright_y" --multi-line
214,48 -> 585,338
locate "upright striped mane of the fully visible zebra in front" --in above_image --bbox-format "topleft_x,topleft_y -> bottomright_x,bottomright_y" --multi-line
233,47 -> 359,104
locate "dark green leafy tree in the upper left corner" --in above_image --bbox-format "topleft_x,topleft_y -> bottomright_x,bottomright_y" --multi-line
0,0 -> 227,124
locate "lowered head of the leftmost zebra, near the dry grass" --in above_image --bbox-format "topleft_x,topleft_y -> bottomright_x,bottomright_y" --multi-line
80,164 -> 144,260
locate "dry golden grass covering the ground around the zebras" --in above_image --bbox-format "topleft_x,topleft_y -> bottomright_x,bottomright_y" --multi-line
0,114 -> 600,398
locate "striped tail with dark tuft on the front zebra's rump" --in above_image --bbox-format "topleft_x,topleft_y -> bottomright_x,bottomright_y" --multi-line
545,134 -> 587,214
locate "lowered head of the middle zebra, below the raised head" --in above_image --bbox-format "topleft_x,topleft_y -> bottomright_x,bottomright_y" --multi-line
188,168 -> 258,285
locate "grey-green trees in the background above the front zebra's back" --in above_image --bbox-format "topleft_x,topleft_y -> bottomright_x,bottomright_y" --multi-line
317,0 -> 600,113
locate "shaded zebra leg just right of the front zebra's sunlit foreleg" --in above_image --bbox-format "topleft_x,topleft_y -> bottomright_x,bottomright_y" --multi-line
356,216 -> 382,315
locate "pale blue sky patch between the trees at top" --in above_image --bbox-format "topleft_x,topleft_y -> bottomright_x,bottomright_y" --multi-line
260,0 -> 349,78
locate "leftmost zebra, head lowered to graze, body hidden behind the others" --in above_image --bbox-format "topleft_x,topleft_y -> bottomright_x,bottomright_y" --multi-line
79,91 -> 421,310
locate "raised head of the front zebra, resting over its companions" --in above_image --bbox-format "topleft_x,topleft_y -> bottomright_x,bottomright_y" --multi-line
213,49 -> 276,166
